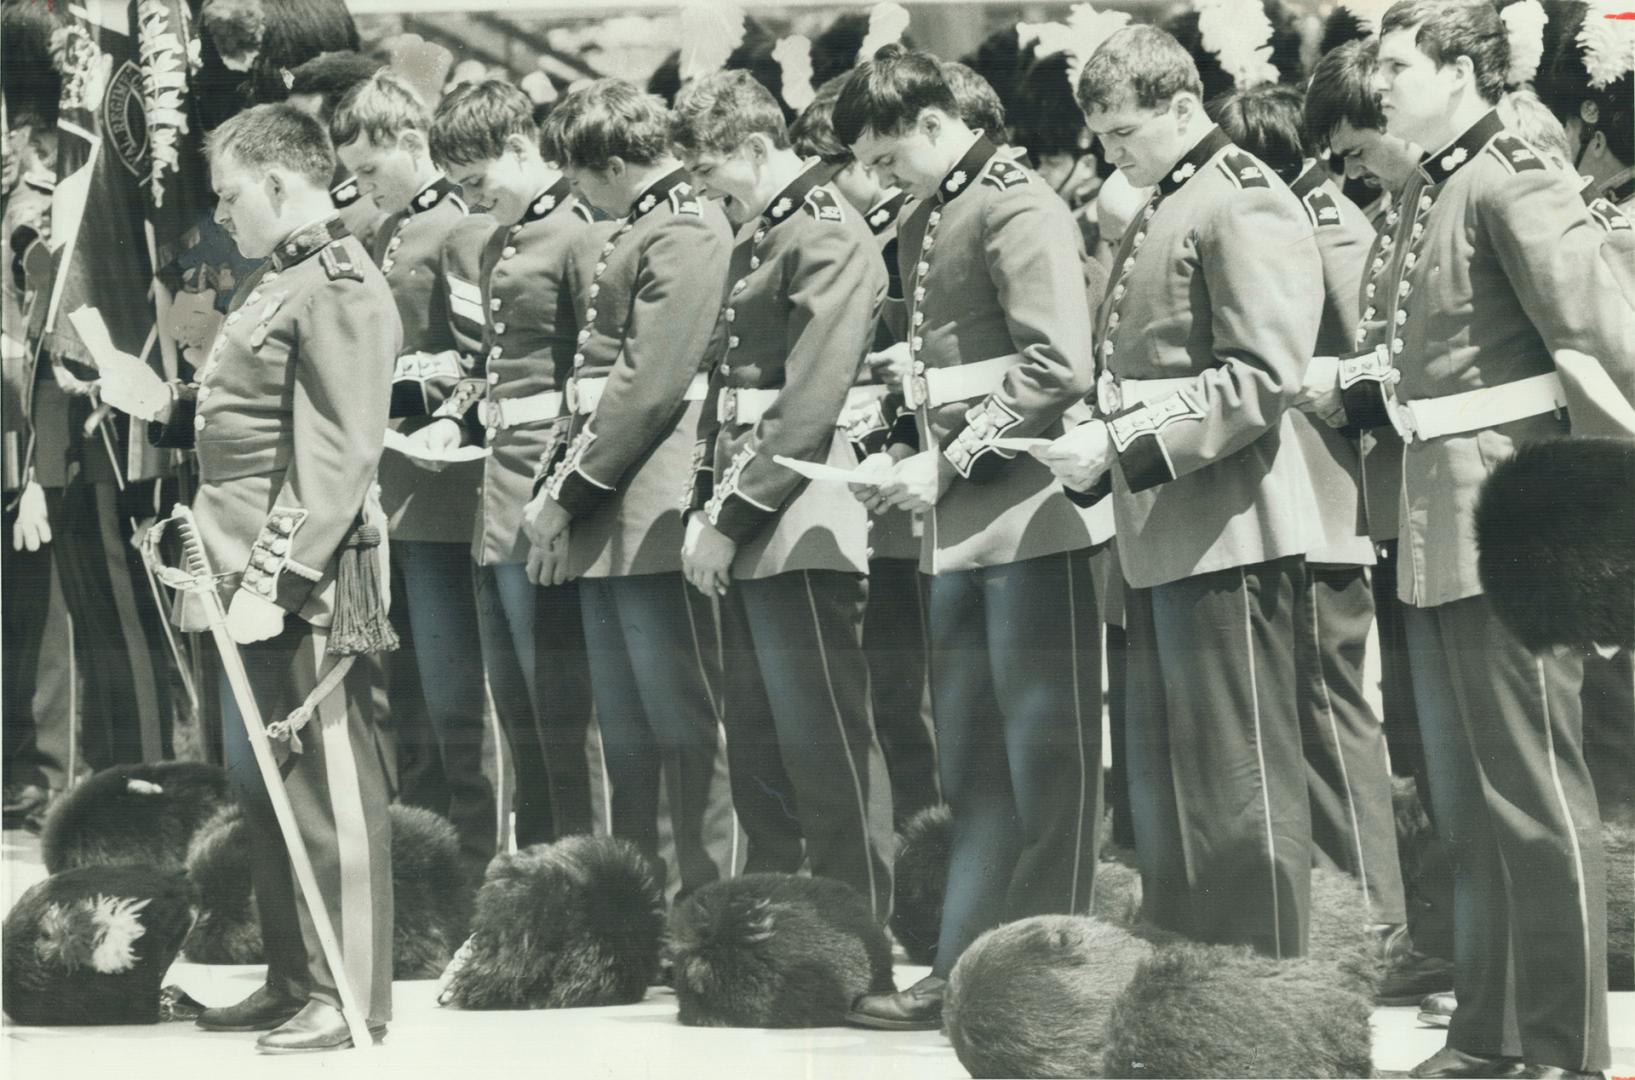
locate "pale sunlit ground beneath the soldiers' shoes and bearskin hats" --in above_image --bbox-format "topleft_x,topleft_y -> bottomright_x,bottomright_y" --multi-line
0,832 -> 1635,1080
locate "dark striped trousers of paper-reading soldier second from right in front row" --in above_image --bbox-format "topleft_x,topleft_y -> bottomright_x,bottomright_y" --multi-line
1125,557 -> 1311,957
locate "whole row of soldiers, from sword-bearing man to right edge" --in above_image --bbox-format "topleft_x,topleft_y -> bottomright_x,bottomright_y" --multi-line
0,0 -> 1635,1075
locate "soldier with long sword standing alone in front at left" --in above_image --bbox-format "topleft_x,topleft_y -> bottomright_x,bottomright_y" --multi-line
137,105 -> 402,1052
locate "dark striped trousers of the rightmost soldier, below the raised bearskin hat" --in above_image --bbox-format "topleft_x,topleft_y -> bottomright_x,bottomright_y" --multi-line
1406,596 -> 1610,1070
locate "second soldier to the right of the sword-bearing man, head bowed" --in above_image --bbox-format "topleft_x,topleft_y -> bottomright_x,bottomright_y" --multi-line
422,82 -> 611,846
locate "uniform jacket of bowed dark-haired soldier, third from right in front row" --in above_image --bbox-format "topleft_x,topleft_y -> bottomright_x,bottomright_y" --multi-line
898,137 -> 1092,573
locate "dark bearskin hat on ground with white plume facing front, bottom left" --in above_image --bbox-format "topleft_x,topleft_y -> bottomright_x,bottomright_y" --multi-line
0,866 -> 193,1024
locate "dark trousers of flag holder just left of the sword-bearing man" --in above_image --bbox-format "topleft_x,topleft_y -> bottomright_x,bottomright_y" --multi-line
46,480 -> 172,770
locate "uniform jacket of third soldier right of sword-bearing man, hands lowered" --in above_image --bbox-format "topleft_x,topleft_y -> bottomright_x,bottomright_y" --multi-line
546,168 -> 732,577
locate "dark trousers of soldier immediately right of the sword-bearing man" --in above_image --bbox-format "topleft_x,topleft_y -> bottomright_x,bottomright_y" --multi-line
389,541 -> 495,871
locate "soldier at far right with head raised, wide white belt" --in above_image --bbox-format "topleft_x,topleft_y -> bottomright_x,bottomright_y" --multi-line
1360,0 -> 1635,1077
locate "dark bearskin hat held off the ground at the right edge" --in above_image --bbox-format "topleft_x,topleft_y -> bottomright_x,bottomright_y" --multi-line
1476,436 -> 1635,652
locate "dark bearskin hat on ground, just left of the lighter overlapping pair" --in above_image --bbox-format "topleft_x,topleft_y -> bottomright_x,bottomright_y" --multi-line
669,874 -> 896,1028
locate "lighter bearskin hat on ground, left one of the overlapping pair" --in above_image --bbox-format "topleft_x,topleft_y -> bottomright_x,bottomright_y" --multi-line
942,915 -> 1153,1077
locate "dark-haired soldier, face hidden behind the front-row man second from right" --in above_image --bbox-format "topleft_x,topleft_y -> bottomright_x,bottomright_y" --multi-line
1208,85 -> 1424,941
